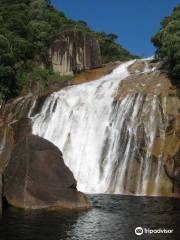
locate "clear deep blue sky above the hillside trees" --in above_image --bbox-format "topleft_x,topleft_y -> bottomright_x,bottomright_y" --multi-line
51,0 -> 180,57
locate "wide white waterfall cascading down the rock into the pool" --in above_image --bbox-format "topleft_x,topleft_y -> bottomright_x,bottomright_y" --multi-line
32,60 -> 165,195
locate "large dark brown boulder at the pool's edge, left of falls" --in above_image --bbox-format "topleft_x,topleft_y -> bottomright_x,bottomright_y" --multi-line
4,135 -> 90,210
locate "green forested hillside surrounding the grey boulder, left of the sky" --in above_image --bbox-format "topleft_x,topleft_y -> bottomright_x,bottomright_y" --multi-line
0,0 -> 133,99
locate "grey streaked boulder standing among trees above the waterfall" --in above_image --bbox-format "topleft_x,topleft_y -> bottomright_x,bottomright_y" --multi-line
49,31 -> 101,75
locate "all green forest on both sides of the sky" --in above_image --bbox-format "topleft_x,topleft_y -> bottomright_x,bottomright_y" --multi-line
0,0 -> 180,100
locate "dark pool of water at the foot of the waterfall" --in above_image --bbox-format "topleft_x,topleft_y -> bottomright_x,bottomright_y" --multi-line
0,195 -> 180,240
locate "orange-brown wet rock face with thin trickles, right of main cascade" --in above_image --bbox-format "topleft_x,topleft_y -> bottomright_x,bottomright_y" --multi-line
117,61 -> 180,197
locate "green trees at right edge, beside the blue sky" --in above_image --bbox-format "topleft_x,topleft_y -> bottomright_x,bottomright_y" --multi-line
152,5 -> 180,82
